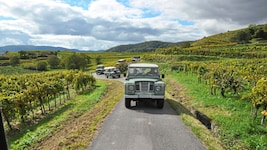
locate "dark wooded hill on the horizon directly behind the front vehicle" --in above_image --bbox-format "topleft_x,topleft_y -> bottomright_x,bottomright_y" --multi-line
106,41 -> 186,52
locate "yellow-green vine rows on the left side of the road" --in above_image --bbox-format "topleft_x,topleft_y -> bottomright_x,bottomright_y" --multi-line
0,71 -> 96,129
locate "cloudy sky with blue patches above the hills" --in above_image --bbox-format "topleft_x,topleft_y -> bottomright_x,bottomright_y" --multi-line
0,0 -> 267,50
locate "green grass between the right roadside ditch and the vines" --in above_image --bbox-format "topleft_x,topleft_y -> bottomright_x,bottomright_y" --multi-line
171,72 -> 267,150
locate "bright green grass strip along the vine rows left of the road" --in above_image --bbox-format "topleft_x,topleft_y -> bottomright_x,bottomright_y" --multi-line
8,81 -> 107,149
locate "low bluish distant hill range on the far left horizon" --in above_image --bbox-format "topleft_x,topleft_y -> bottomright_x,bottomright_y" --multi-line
0,45 -> 99,54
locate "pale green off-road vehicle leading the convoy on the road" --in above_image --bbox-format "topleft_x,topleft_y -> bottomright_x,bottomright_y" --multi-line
124,63 -> 165,108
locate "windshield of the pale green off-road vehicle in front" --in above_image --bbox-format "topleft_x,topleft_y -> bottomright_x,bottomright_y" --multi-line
128,67 -> 159,77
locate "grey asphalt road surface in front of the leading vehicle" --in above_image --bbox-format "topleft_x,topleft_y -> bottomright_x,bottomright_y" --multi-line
88,74 -> 206,150
